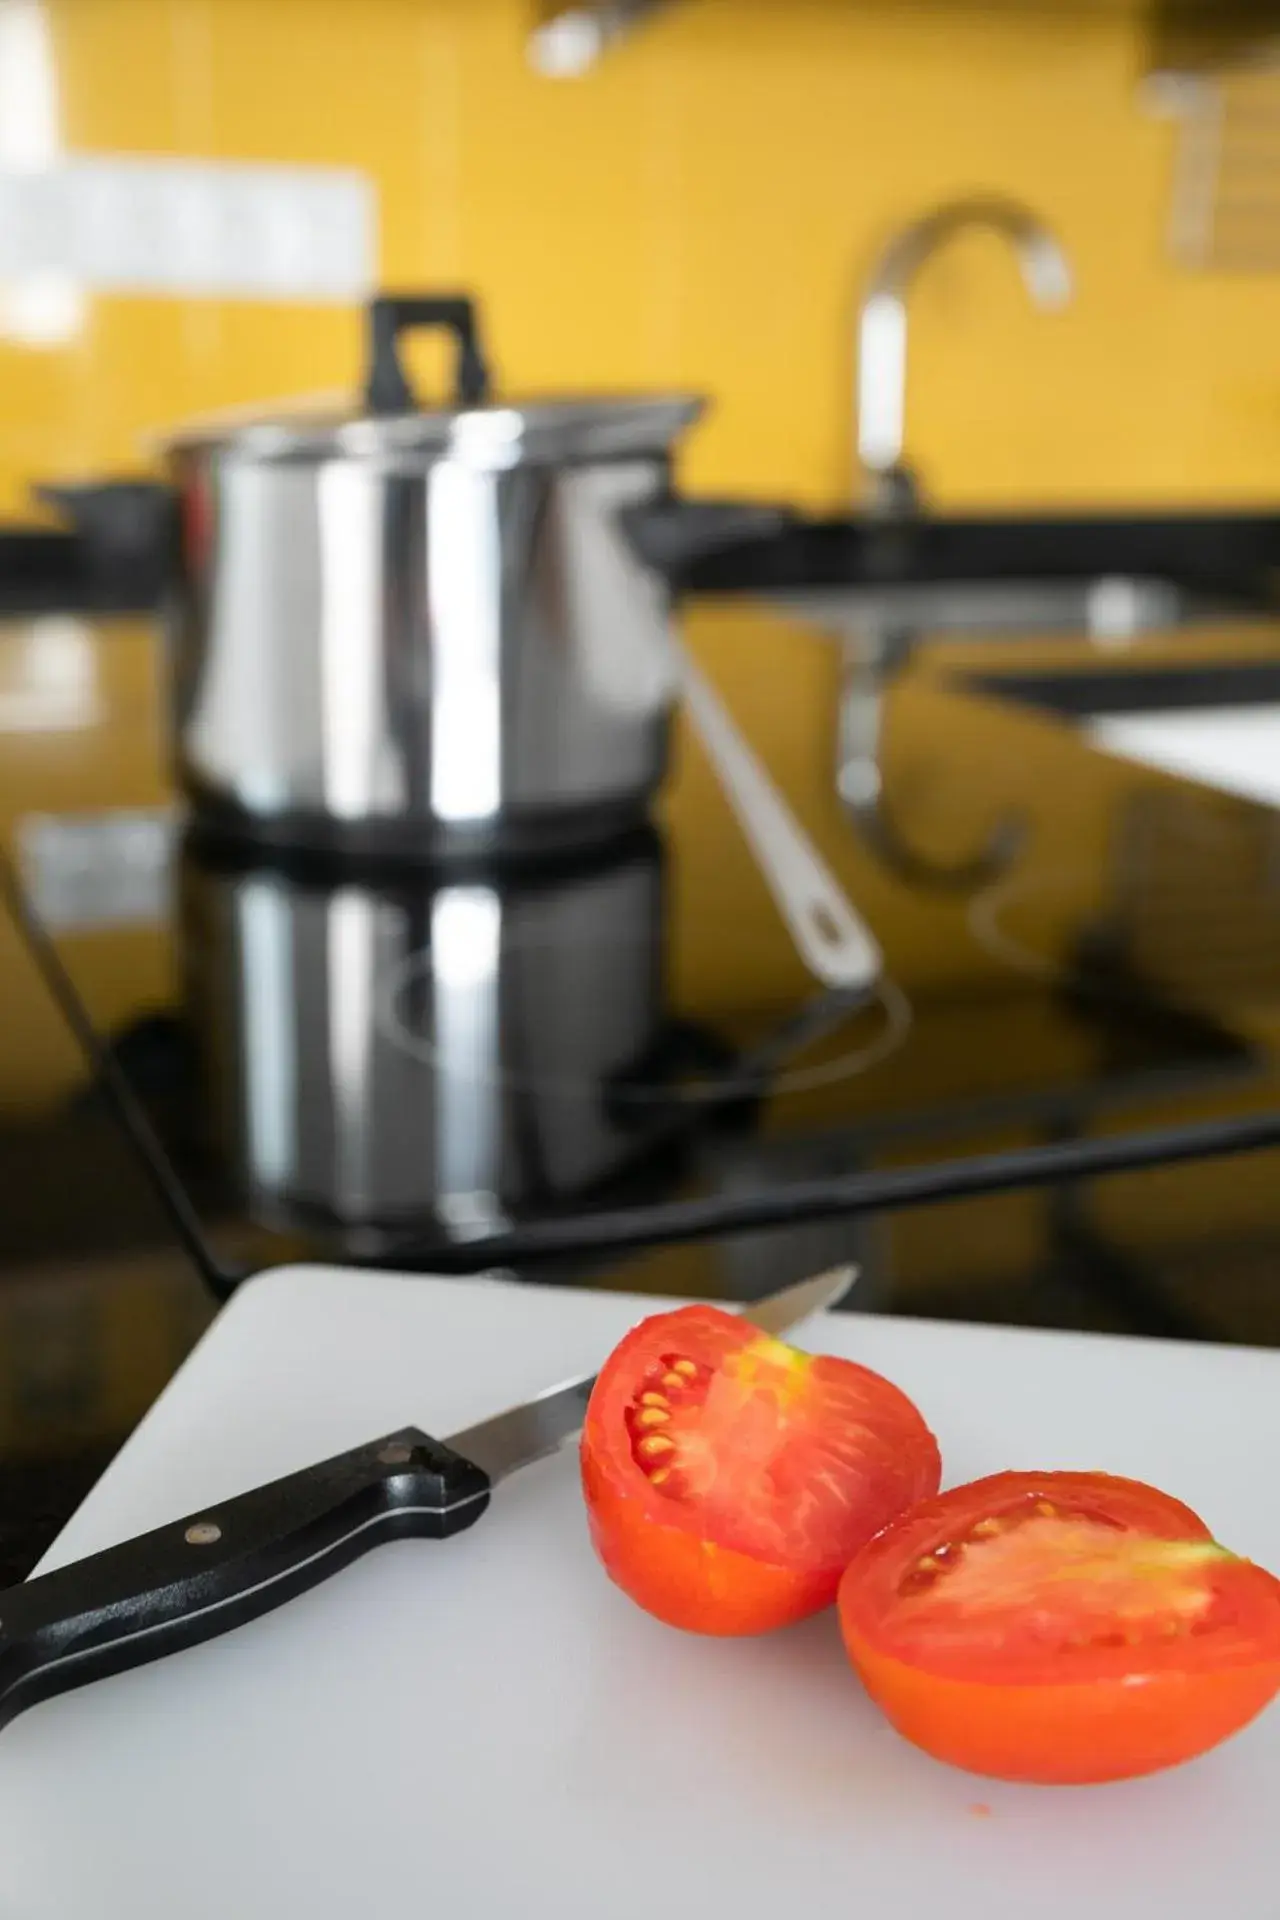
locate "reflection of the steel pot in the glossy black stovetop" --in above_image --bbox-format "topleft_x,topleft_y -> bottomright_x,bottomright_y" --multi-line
178,833 -> 679,1252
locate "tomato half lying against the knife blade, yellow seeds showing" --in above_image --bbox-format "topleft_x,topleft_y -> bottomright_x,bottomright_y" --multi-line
581,1308 -> 940,1634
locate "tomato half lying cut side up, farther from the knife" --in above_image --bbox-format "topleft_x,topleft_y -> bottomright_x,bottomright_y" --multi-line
841,1473 -> 1280,1782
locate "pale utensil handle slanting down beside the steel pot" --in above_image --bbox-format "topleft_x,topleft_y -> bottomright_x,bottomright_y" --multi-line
672,641 -> 885,989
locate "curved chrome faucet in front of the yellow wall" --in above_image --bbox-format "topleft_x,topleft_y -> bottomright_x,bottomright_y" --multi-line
856,194 -> 1071,511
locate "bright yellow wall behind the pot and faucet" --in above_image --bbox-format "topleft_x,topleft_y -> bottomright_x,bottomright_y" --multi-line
0,0 -> 1280,511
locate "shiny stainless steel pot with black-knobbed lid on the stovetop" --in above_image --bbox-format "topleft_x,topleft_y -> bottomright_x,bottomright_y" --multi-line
169,298 -> 779,856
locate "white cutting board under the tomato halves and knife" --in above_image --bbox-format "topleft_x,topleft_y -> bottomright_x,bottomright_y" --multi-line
0,1267 -> 1280,1920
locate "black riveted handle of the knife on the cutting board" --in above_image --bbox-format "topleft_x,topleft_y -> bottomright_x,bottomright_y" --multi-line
0,1427 -> 489,1726
